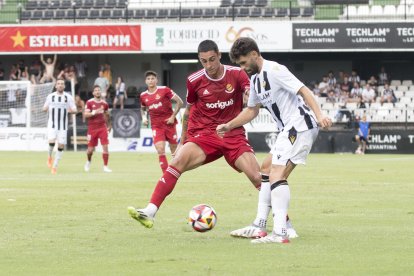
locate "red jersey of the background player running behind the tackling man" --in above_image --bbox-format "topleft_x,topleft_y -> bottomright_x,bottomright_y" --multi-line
140,86 -> 177,127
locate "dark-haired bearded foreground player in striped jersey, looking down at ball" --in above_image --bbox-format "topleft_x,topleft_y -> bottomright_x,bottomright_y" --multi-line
217,37 -> 332,243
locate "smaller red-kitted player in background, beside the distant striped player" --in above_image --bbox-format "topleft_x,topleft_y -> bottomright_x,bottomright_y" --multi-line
84,85 -> 112,173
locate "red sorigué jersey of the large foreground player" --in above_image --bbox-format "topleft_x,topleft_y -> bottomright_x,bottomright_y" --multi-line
187,65 -> 250,135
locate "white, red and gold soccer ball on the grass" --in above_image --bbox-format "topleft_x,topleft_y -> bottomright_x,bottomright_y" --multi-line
188,204 -> 217,232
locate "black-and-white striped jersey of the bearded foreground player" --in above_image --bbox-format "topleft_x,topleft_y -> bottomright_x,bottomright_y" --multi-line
247,60 -> 317,131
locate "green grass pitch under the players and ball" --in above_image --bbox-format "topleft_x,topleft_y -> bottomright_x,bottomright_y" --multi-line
0,152 -> 414,275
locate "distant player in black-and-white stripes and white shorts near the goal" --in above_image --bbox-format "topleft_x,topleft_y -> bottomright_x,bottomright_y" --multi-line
43,78 -> 77,174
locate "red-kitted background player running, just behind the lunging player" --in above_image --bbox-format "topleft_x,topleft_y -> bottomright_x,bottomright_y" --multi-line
140,71 -> 183,173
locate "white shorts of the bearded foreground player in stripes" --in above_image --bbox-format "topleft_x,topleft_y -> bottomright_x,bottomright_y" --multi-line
270,128 -> 319,166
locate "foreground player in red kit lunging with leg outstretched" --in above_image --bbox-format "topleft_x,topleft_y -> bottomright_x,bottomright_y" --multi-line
128,40 -> 261,228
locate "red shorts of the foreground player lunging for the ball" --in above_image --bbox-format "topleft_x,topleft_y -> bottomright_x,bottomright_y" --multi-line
186,133 -> 254,172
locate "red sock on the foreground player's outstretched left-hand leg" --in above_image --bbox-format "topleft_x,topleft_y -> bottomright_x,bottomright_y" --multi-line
150,166 -> 181,208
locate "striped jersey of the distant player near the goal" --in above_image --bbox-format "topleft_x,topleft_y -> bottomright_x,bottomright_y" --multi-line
43,92 -> 76,130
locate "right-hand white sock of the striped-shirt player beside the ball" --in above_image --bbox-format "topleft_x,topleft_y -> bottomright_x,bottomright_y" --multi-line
271,180 -> 290,236
